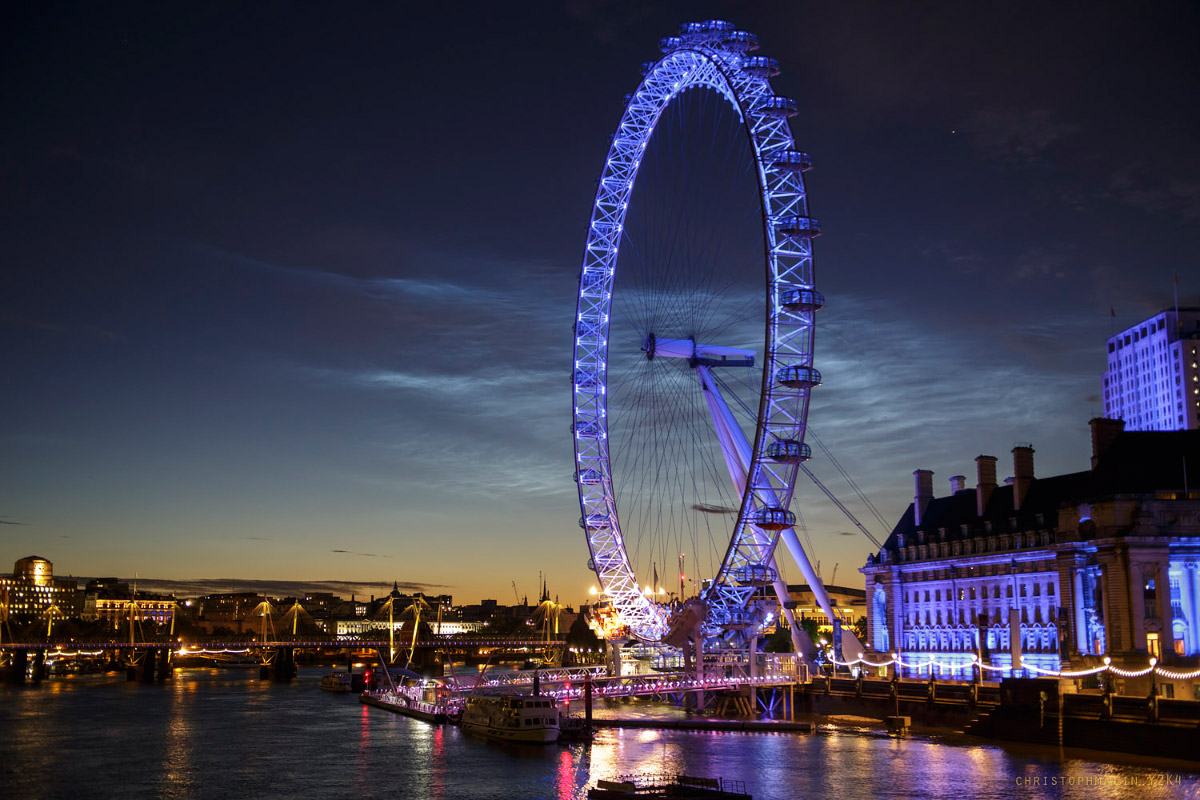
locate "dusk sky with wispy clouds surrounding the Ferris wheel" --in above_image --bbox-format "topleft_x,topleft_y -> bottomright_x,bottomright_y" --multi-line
0,0 -> 1200,602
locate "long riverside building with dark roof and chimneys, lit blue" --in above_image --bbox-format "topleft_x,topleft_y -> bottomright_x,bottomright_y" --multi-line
862,419 -> 1200,697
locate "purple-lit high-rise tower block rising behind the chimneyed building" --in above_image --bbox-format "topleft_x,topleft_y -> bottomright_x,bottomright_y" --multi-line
1104,308 -> 1200,431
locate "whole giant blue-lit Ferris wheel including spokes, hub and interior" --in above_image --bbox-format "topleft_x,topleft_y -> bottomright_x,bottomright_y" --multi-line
571,20 -> 823,642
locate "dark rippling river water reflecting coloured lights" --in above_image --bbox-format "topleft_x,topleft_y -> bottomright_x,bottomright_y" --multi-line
0,669 -> 1200,800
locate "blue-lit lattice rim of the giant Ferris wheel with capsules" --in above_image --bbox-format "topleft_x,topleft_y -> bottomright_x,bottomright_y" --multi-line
571,22 -> 820,640
